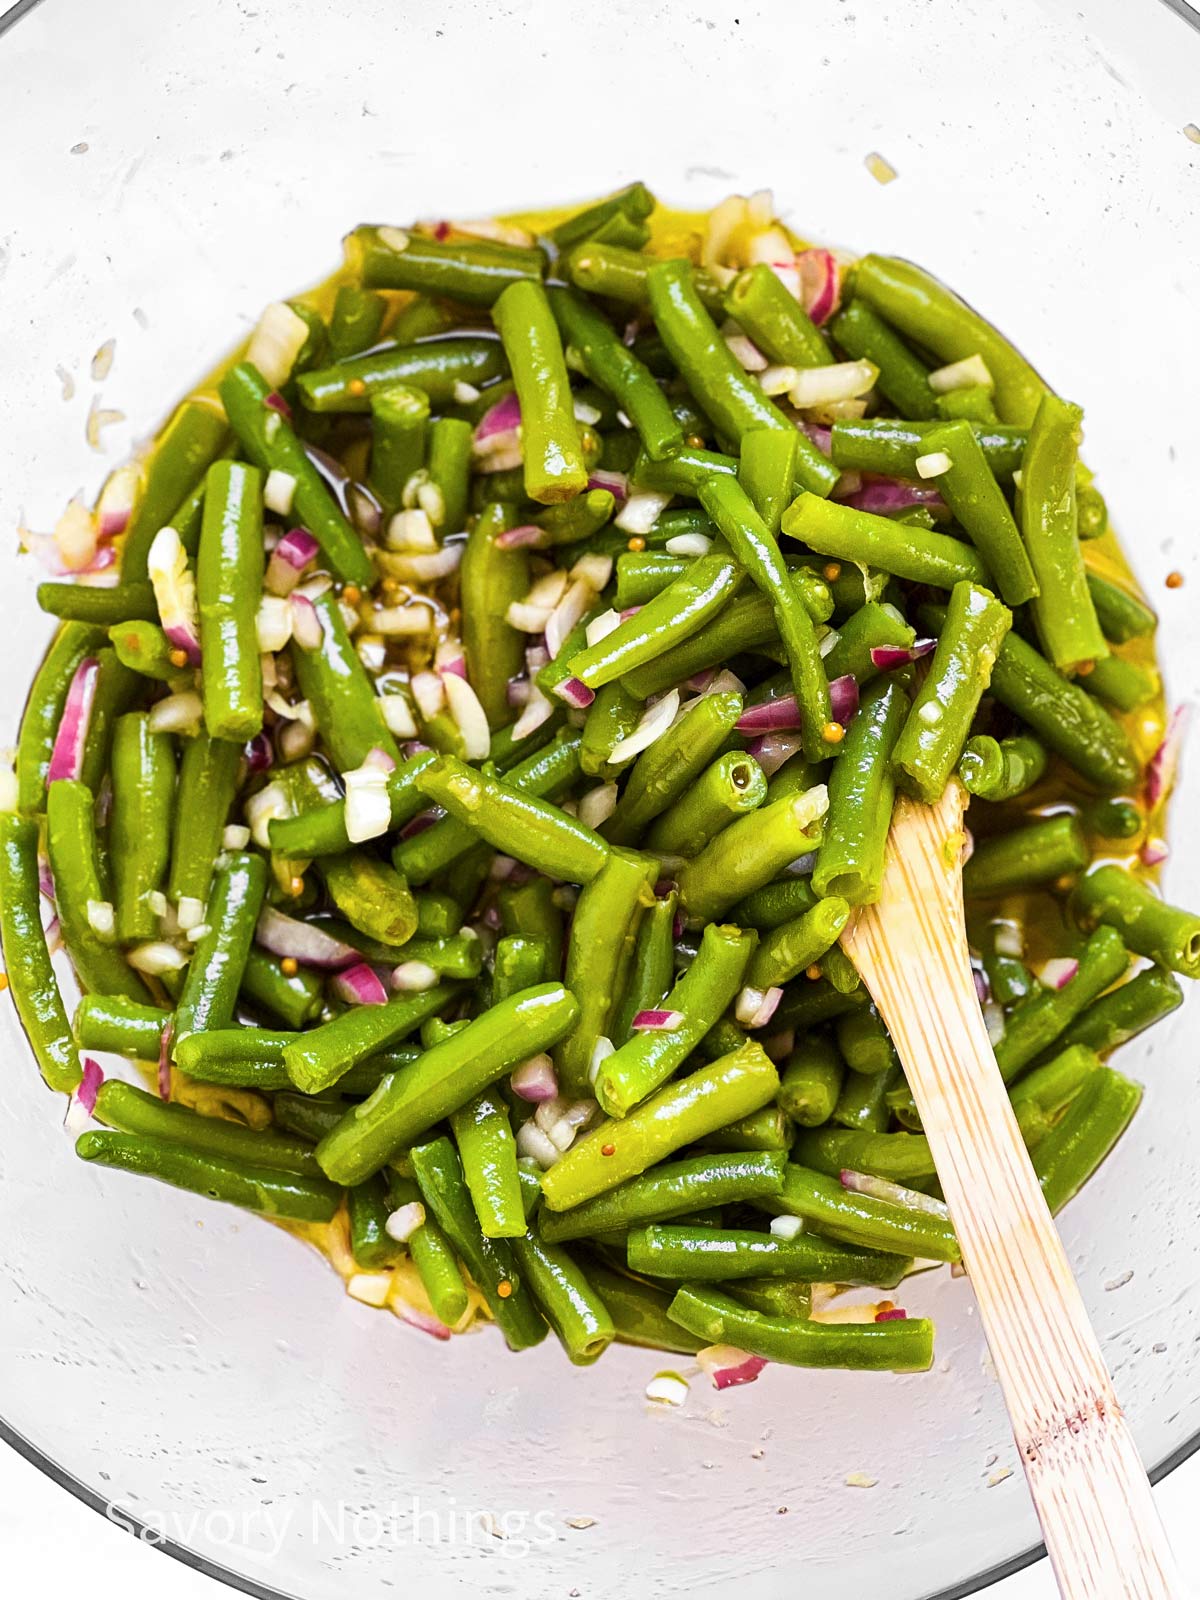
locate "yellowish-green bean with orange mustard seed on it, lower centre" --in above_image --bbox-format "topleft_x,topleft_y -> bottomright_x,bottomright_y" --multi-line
542,1043 -> 779,1211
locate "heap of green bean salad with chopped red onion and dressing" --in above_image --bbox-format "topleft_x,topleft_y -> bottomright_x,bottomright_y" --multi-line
0,184 -> 1200,1387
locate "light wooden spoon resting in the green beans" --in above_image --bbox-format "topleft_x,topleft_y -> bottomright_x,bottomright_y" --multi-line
842,781 -> 1187,1600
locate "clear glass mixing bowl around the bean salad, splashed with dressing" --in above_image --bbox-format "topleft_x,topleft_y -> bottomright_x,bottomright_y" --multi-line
0,0 -> 1200,1600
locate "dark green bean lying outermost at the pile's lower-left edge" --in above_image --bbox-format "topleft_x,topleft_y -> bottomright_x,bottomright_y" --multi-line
75,1131 -> 341,1222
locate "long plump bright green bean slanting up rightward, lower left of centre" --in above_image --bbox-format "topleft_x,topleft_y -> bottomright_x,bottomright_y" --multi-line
316,984 -> 579,1182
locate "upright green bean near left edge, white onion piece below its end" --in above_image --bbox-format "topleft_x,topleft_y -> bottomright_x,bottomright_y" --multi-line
109,712 -> 174,944
